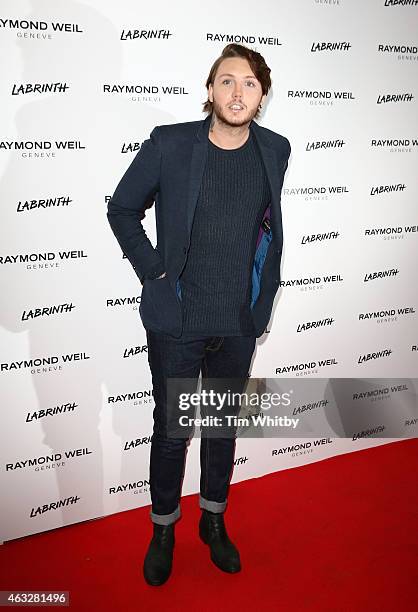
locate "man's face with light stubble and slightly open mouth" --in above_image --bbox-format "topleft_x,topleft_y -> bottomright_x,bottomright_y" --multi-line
208,57 -> 265,127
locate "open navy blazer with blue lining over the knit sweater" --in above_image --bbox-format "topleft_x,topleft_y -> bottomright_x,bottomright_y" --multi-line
107,115 -> 290,338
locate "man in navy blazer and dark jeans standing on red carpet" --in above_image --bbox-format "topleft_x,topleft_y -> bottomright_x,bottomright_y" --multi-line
108,44 -> 290,585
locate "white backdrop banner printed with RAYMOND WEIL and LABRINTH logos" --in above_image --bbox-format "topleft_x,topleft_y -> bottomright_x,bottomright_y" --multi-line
0,0 -> 418,541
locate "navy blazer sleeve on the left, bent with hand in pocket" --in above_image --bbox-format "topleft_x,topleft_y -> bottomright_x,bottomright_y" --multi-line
107,126 -> 165,283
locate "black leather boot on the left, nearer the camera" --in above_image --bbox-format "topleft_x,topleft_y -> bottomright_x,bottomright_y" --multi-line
143,523 -> 174,586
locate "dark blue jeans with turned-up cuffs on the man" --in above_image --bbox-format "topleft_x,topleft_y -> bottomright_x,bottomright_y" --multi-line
147,330 -> 256,525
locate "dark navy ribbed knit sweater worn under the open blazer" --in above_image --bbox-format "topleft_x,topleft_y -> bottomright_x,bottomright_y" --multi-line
180,132 -> 270,336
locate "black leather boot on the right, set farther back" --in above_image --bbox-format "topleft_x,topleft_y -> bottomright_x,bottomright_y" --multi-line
199,510 -> 241,574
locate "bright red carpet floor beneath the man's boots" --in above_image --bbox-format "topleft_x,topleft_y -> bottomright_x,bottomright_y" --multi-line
0,440 -> 418,612
